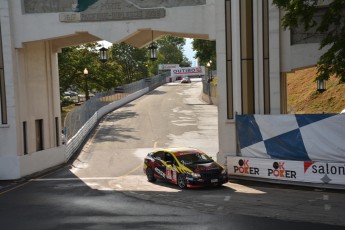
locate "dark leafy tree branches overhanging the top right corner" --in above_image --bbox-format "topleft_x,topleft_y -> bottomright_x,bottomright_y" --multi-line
273,0 -> 345,83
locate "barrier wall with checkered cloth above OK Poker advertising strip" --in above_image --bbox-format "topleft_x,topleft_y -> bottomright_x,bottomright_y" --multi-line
227,114 -> 345,188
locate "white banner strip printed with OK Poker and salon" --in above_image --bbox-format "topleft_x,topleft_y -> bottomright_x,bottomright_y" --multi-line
227,157 -> 345,185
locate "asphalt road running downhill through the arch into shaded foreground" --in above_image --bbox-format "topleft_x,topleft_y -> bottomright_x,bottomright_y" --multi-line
0,79 -> 345,230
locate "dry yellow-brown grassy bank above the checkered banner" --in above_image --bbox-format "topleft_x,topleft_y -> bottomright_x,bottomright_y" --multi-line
287,67 -> 345,114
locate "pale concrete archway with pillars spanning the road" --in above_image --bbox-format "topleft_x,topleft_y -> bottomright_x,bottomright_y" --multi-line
0,0 -> 321,180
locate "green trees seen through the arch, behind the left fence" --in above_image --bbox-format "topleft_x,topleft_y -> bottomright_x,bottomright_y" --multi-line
58,36 -> 191,96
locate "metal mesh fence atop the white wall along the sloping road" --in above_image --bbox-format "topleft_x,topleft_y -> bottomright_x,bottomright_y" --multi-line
64,75 -> 167,142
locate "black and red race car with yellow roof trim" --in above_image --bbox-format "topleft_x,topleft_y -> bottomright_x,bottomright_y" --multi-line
144,147 -> 228,189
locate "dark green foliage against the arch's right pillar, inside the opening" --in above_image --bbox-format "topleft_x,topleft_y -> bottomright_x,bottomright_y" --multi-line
192,39 -> 217,69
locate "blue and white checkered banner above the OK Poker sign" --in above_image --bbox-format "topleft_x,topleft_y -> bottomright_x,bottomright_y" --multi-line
236,114 -> 345,162
